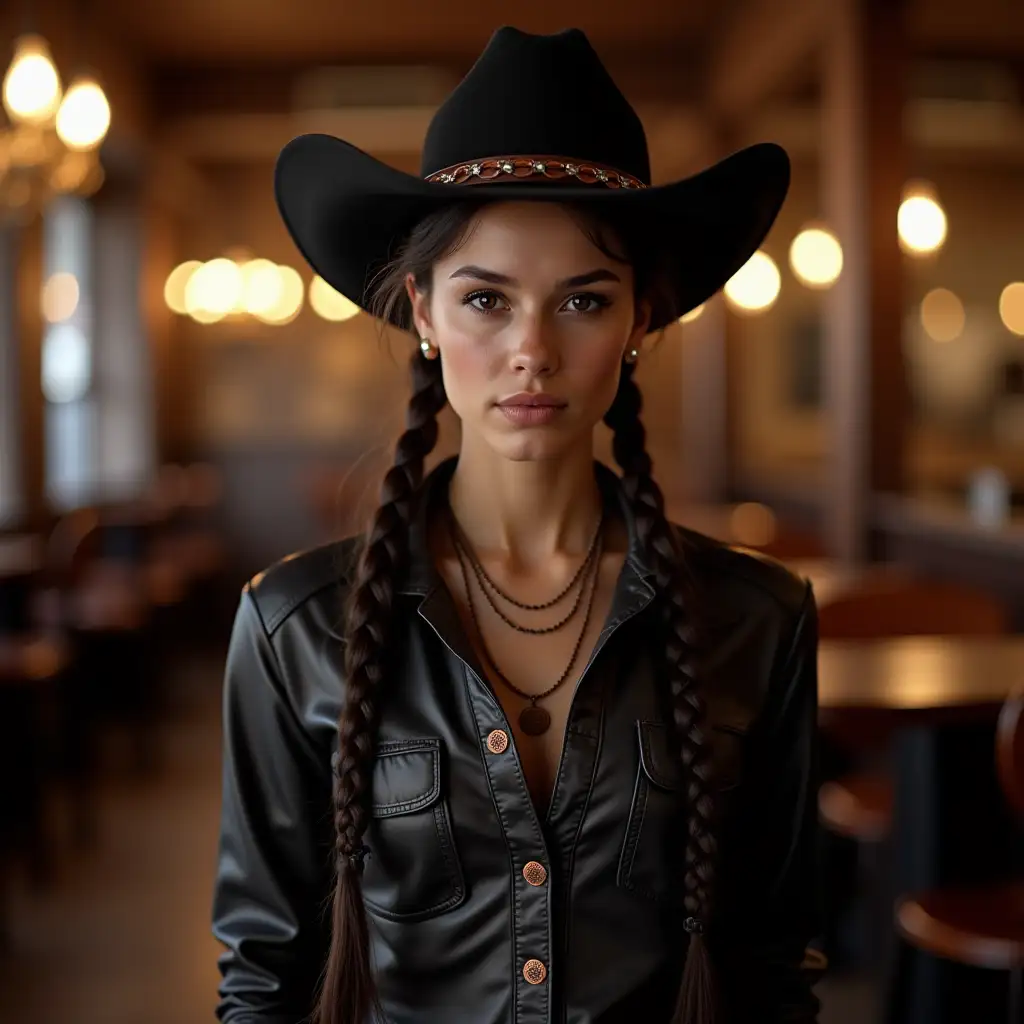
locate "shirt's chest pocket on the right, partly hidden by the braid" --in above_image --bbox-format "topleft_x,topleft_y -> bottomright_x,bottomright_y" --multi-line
616,721 -> 744,904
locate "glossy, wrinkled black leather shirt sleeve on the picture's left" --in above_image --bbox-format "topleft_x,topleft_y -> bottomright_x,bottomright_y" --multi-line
213,586 -> 333,1024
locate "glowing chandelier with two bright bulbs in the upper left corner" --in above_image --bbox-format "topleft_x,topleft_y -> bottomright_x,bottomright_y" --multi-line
0,35 -> 111,223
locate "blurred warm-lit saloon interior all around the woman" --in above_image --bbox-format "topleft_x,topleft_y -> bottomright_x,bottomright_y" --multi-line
0,0 -> 1024,1024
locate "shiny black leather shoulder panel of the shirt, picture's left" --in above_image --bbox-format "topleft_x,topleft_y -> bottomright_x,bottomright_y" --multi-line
244,537 -> 359,636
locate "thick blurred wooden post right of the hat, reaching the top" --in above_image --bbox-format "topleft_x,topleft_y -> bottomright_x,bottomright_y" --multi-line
821,0 -> 909,562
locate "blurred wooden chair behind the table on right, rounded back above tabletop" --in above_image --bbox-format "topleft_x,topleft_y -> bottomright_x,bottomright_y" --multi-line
818,572 -> 1010,843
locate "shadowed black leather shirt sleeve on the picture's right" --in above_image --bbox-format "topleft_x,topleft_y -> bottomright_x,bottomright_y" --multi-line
712,585 -> 825,1024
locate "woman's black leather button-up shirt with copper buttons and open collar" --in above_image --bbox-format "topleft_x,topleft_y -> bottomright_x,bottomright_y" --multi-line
213,458 -> 818,1024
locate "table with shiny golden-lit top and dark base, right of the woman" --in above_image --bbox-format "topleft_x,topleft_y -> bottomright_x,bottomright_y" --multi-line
818,637 -> 1024,1024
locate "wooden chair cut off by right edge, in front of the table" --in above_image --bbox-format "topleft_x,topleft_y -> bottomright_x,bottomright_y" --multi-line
895,686 -> 1024,1024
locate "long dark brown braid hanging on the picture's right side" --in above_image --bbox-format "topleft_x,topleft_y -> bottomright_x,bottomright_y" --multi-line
604,364 -> 717,1024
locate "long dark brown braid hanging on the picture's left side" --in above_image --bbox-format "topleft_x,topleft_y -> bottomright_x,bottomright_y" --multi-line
313,348 -> 447,1024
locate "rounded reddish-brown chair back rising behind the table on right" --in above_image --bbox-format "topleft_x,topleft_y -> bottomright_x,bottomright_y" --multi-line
818,575 -> 1010,640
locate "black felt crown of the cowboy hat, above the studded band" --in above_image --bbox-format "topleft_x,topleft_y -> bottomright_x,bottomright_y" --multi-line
421,26 -> 650,184
